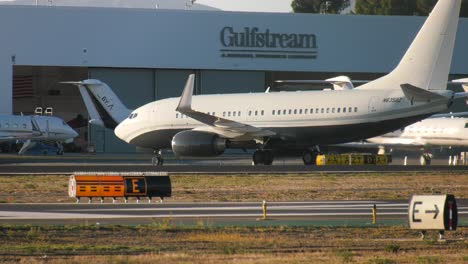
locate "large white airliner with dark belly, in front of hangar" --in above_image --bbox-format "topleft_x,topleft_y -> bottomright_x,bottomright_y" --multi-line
69,0 -> 467,164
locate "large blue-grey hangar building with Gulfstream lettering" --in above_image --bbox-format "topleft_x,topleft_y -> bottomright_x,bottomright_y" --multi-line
0,0 -> 468,152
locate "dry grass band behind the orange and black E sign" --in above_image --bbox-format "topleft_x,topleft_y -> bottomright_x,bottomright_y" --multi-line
0,172 -> 468,203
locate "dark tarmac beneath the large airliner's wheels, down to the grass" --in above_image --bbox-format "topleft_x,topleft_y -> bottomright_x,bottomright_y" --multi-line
0,154 -> 468,175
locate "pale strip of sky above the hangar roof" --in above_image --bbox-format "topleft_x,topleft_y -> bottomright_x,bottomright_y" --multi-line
196,0 -> 292,13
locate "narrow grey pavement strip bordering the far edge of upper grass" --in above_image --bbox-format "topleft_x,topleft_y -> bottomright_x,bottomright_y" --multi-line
0,163 -> 468,175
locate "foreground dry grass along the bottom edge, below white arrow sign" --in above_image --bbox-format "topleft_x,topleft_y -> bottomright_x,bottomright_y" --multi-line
0,225 -> 468,263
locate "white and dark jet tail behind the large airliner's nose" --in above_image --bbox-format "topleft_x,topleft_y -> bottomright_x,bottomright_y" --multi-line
63,79 -> 132,129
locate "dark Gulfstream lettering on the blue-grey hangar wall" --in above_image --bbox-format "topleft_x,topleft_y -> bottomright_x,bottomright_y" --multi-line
220,27 -> 317,59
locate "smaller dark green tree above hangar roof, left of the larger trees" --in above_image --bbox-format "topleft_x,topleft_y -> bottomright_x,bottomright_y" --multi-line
291,0 -> 349,14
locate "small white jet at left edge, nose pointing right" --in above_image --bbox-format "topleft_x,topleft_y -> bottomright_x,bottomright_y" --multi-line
0,115 -> 78,155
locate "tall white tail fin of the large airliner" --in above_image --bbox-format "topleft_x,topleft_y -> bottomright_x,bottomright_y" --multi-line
359,0 -> 461,91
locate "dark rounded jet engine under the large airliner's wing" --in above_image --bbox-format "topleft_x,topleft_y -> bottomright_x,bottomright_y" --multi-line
171,130 -> 227,157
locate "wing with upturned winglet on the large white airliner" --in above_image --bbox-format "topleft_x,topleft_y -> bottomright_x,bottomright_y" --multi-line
176,74 -> 275,138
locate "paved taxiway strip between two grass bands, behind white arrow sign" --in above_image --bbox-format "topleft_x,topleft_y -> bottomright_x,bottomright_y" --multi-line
0,200 -> 468,226
